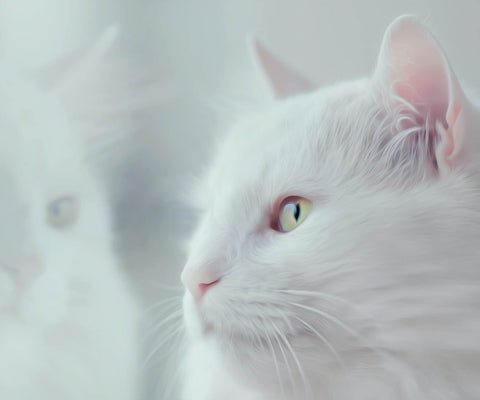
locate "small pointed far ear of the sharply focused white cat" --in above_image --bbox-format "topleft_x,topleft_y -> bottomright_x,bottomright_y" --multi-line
248,36 -> 315,99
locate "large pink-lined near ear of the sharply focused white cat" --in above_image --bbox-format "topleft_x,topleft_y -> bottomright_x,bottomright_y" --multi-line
373,16 -> 468,173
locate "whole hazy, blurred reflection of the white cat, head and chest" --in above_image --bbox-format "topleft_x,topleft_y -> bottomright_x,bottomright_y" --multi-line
0,30 -> 138,400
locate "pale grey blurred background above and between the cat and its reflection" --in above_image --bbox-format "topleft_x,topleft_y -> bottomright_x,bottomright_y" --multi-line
0,0 -> 480,399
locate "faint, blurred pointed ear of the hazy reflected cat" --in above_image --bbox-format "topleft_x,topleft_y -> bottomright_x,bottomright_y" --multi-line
34,25 -> 119,93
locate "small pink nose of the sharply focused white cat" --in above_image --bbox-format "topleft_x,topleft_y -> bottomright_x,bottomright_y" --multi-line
182,262 -> 220,303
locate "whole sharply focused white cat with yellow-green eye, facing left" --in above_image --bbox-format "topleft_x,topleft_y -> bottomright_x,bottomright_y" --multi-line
182,17 -> 480,400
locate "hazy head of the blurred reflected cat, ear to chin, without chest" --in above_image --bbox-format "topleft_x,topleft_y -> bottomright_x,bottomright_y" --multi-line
0,30 -> 125,324
